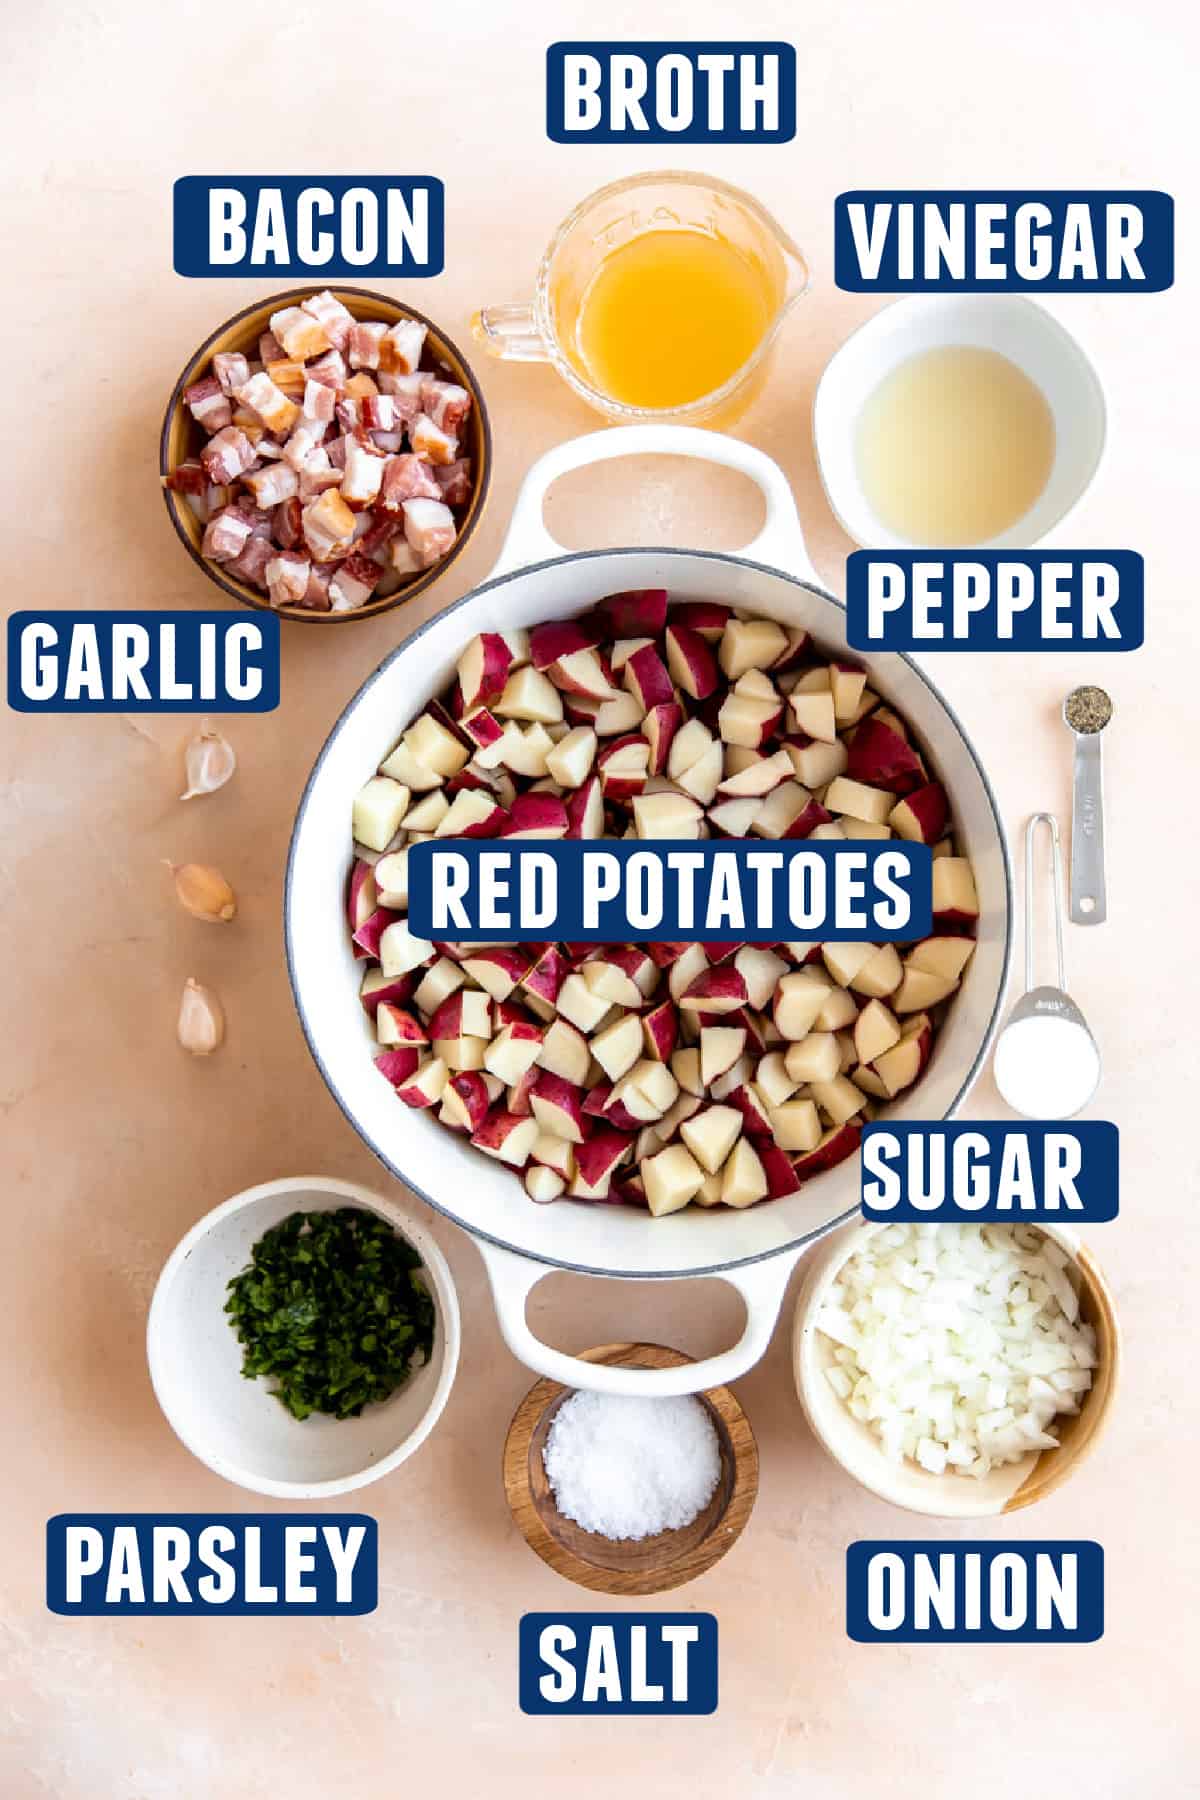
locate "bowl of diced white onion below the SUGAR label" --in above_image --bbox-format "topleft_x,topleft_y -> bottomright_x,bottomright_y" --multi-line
792,1222 -> 1121,1519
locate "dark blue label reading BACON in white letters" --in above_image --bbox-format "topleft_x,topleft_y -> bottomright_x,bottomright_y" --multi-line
175,175 -> 446,281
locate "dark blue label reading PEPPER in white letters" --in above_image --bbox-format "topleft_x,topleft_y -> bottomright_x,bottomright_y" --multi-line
846,551 -> 1144,650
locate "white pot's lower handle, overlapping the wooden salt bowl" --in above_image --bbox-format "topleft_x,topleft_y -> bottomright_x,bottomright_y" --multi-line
475,1238 -> 801,1400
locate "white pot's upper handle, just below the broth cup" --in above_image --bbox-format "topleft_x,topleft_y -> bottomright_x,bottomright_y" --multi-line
491,425 -> 820,587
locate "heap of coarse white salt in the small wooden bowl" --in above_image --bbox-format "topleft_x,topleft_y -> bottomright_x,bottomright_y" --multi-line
543,1393 -> 721,1539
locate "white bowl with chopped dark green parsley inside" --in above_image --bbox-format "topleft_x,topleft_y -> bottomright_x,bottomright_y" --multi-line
146,1175 -> 459,1499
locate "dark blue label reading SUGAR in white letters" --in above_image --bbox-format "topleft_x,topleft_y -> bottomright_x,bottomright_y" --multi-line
862,1120 -> 1119,1224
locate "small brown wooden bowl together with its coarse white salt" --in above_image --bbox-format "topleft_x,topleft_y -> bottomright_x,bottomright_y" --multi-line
504,1345 -> 757,1595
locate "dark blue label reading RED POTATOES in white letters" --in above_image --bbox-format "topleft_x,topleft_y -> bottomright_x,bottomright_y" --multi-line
408,837 -> 932,943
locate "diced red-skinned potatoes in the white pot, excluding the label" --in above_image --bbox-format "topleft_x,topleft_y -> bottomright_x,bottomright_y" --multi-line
345,590 -> 977,1215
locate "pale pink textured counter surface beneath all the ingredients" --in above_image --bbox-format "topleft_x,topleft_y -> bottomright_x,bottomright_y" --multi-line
0,0 -> 1200,1800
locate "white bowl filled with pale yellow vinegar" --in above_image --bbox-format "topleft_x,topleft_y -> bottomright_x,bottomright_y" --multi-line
813,293 -> 1105,549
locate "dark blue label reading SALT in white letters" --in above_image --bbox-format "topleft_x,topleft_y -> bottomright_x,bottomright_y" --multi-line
520,1613 -> 716,1714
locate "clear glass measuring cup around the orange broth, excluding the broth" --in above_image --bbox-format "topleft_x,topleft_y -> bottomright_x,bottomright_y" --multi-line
471,171 -> 810,425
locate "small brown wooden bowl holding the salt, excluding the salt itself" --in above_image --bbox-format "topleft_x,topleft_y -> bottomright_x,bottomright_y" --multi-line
504,1345 -> 757,1595
